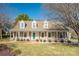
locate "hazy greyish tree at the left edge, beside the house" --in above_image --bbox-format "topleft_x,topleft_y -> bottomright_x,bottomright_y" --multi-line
0,13 -> 12,38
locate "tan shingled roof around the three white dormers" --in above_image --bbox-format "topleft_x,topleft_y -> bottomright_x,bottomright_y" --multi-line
11,20 -> 68,31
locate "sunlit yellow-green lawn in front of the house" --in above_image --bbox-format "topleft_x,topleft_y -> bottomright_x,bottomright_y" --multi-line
0,41 -> 79,56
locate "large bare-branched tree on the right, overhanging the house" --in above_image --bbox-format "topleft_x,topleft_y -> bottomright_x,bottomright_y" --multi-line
43,3 -> 79,42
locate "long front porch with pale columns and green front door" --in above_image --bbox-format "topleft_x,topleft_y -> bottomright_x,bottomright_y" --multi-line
10,31 -> 71,41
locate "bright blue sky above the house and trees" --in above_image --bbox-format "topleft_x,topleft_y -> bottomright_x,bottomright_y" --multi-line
0,3 -> 47,19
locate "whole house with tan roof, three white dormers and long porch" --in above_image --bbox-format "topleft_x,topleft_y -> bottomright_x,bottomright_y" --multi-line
10,20 -> 71,41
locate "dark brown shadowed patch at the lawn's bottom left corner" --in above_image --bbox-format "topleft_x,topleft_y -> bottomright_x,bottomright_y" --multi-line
0,44 -> 21,56
